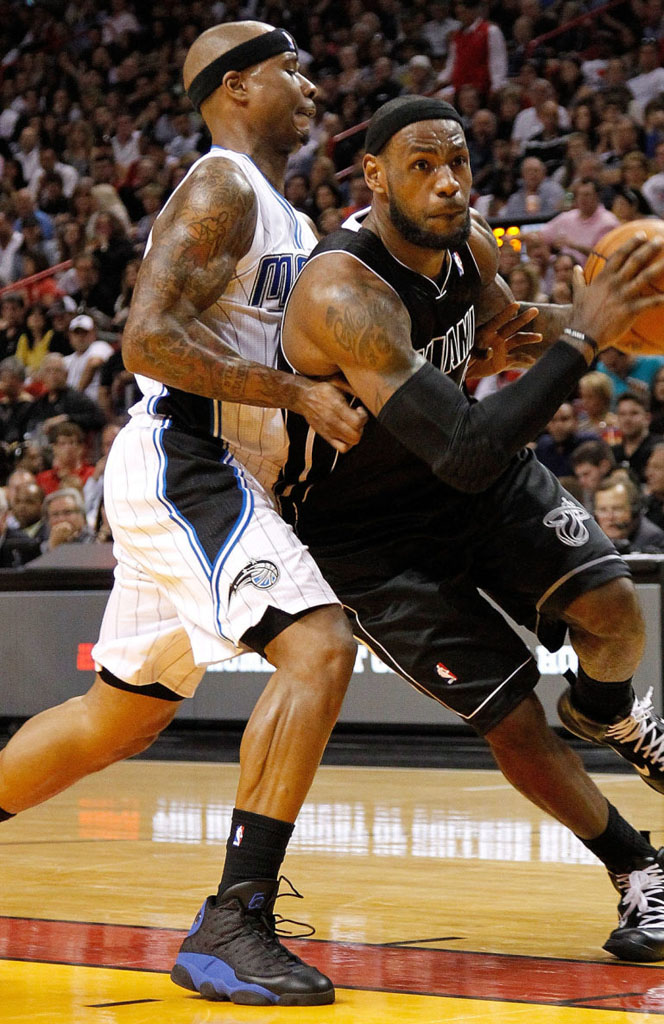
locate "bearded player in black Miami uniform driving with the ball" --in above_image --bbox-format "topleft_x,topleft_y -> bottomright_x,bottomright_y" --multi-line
279,97 -> 664,961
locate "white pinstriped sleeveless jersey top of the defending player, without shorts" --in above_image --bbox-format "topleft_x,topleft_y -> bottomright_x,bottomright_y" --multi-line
132,146 -> 317,487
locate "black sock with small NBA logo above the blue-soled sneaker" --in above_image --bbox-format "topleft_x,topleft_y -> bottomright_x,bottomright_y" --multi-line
217,808 -> 295,899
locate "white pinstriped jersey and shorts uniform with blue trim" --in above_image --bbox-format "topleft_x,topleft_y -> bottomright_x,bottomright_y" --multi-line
93,147 -> 337,699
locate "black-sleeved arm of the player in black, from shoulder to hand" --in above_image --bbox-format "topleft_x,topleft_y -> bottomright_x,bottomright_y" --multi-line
284,240 -> 664,492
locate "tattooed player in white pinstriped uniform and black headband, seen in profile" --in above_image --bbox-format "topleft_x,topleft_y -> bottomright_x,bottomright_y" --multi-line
0,22 -> 365,1005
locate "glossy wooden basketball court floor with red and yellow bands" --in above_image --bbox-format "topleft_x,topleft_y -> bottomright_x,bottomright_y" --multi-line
0,761 -> 664,1024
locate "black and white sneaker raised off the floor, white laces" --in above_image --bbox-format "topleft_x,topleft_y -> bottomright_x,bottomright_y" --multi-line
557,686 -> 664,794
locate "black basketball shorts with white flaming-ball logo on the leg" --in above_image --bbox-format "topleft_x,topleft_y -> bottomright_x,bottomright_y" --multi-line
304,450 -> 630,734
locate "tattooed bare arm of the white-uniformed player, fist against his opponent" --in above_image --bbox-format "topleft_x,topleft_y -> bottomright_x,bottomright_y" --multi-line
123,158 -> 364,451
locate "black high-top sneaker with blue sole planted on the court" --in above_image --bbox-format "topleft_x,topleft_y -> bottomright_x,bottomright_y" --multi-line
171,879 -> 334,1007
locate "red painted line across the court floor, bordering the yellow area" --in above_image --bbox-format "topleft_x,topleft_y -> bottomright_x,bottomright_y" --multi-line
0,916 -> 664,1014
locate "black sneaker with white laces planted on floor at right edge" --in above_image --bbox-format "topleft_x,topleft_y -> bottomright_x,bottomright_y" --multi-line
604,848 -> 664,963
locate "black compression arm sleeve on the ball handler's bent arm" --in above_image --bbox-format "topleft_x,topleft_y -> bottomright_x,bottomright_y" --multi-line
378,341 -> 588,494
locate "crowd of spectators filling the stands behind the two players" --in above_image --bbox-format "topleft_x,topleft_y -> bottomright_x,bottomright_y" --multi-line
0,0 -> 664,566
